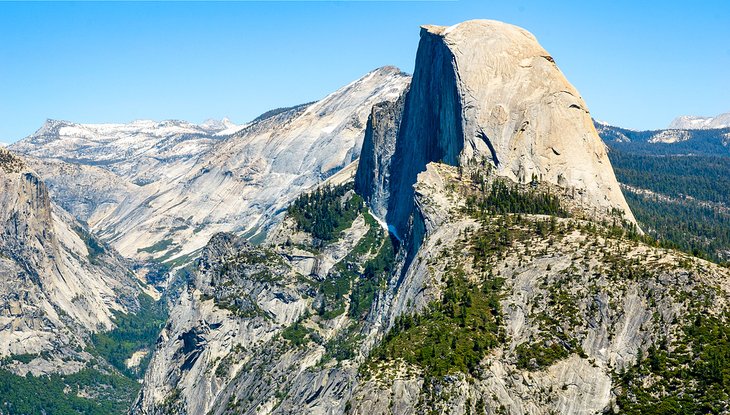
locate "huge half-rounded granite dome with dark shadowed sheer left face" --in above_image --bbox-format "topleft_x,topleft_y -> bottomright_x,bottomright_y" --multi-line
388,20 -> 634,237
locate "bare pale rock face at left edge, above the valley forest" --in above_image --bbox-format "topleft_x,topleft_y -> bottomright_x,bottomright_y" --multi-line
0,149 -> 144,373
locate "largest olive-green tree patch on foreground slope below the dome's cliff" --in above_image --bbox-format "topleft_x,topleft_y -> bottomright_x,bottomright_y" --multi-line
370,270 -> 504,376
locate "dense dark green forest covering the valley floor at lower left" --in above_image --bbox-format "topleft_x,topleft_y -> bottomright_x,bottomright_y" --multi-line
0,294 -> 167,415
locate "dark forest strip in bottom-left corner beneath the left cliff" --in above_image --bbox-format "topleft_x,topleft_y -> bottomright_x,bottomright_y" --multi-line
0,368 -> 140,415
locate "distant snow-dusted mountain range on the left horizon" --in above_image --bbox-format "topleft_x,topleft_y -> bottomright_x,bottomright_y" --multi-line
10,120 -> 236,229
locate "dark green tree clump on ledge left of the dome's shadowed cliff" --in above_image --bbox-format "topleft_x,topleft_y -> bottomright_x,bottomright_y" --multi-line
288,184 -> 364,241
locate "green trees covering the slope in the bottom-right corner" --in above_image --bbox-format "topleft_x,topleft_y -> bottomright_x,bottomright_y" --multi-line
616,310 -> 730,415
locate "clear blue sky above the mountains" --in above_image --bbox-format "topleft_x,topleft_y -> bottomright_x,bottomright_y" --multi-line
0,0 -> 730,142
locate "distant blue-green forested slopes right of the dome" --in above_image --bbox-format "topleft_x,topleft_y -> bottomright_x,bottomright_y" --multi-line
596,122 -> 730,263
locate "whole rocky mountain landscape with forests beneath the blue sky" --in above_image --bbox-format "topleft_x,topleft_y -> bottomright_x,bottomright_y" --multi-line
0,15 -> 730,415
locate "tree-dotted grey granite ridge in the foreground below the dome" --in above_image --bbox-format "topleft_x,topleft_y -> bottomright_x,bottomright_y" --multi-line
132,163 -> 730,414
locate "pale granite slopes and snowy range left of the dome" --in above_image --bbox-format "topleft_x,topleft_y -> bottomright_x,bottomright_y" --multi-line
12,67 -> 410,261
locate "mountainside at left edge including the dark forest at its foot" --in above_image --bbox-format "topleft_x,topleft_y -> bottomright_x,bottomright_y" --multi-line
0,149 -> 164,413
